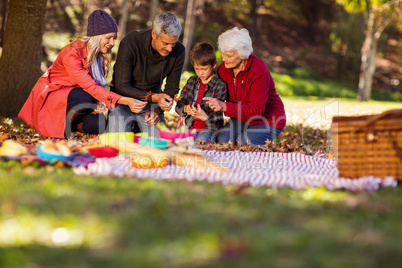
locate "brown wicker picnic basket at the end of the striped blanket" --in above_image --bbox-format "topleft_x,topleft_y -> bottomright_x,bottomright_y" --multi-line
330,109 -> 402,180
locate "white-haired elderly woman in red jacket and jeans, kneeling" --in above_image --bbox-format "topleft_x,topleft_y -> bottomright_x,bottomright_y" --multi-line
203,27 -> 286,145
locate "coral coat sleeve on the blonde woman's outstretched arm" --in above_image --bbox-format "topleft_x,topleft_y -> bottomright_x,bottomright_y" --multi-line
63,50 -> 121,108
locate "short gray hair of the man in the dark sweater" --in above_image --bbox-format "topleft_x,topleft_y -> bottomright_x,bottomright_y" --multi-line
153,12 -> 181,37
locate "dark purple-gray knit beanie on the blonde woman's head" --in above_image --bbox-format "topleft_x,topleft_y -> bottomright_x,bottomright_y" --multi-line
87,9 -> 117,36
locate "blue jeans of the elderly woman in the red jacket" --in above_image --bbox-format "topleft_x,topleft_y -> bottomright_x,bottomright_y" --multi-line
215,118 -> 282,145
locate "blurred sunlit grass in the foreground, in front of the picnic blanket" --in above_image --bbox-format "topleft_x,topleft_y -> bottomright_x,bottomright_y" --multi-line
0,162 -> 402,267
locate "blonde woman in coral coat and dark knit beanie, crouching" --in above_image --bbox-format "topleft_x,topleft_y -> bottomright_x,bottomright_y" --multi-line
18,10 -> 146,138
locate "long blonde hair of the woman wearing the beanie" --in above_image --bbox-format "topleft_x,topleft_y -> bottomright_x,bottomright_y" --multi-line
70,35 -> 112,77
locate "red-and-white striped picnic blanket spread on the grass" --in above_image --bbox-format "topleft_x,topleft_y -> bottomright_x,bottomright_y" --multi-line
73,151 -> 397,191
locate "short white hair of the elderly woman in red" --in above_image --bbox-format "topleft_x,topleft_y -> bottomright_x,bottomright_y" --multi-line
218,27 -> 253,59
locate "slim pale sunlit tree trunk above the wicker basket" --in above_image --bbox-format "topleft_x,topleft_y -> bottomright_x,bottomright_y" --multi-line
357,9 -> 378,101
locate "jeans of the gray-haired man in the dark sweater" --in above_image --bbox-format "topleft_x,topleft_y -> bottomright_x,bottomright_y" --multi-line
107,104 -> 165,137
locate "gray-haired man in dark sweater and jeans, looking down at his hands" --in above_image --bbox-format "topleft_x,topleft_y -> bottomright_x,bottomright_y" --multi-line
108,12 -> 184,137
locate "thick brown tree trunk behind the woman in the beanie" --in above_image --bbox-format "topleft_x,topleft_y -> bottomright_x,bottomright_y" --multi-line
0,0 -> 47,117
